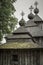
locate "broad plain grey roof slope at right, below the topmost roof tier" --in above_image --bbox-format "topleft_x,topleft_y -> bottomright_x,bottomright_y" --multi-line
27,25 -> 43,37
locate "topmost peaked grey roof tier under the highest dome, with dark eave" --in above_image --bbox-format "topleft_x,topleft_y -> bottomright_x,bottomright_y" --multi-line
25,15 -> 43,27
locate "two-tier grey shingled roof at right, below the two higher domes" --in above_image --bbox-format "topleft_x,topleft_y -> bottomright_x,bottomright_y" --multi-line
26,15 -> 43,37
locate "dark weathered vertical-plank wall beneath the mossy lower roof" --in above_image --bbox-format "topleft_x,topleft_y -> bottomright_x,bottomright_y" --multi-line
0,49 -> 43,65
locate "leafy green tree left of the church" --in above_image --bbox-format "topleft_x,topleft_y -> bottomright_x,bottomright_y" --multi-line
0,0 -> 17,40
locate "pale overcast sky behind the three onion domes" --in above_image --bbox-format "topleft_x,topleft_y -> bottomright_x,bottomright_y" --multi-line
14,0 -> 43,21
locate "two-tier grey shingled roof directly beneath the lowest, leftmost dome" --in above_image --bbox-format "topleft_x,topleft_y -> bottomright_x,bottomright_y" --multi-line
6,27 -> 32,40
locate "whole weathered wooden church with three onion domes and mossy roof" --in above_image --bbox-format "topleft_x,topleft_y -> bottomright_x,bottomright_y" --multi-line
0,2 -> 43,65
